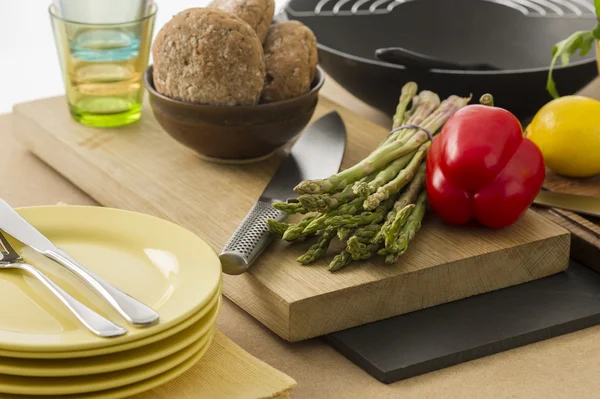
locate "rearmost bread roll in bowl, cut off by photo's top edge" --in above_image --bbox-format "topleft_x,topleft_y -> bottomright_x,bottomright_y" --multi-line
209,0 -> 275,43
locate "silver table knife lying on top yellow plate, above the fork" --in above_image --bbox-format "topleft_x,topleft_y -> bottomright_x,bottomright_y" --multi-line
0,200 -> 159,327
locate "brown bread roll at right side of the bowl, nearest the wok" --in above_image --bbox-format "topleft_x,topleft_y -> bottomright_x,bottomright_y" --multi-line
261,21 -> 317,103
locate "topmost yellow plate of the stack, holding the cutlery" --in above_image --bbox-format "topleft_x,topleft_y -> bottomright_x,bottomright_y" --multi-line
0,206 -> 221,352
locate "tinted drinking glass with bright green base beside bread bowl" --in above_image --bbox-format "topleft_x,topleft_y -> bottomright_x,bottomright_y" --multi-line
50,0 -> 157,127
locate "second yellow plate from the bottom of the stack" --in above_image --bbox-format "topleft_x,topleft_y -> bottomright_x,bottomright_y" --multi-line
0,326 -> 215,398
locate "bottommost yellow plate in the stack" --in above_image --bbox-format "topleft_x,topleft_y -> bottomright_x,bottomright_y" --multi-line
0,336 -> 213,399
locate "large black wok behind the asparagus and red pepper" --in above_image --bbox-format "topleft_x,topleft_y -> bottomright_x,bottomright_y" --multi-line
285,0 -> 598,118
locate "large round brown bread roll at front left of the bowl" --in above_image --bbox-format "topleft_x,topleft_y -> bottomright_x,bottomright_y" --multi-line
152,8 -> 265,106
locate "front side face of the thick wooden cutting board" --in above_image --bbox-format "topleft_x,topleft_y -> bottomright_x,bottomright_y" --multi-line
282,233 -> 571,342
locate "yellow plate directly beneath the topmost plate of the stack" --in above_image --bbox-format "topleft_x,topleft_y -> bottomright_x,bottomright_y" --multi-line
0,287 -> 222,360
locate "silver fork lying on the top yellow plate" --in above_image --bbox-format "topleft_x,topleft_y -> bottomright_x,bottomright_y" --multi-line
0,233 -> 127,338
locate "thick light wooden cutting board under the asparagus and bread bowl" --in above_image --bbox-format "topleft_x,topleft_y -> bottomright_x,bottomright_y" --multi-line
13,97 -> 570,341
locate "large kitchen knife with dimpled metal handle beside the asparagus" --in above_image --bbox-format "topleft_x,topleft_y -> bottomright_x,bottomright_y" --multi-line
219,112 -> 346,274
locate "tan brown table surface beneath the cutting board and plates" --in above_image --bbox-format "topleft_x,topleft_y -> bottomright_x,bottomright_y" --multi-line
0,78 -> 600,399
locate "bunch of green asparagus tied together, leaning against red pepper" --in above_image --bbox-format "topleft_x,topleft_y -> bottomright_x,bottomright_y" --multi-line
267,82 -> 470,272
